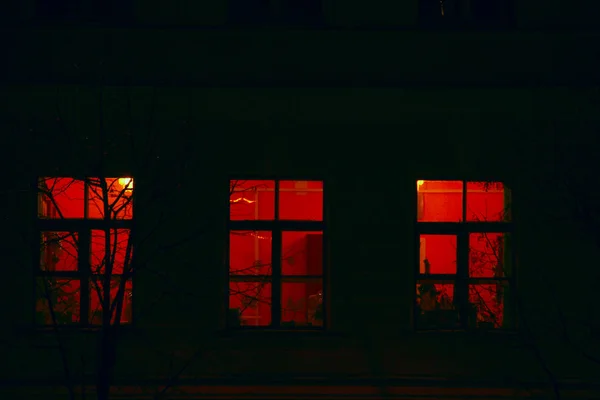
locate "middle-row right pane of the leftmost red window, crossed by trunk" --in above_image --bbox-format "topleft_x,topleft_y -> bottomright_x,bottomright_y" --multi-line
90,229 -> 132,275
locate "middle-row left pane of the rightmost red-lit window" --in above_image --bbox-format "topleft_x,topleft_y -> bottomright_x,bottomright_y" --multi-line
419,235 -> 456,274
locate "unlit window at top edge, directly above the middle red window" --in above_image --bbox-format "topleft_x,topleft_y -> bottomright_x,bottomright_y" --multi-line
229,0 -> 322,25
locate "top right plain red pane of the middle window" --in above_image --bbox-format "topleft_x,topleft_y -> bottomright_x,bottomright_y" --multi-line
279,181 -> 323,221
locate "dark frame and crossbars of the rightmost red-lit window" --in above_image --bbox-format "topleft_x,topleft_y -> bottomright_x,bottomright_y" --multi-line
412,179 -> 517,332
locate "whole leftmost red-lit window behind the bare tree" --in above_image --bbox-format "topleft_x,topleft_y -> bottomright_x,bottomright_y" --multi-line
35,178 -> 133,325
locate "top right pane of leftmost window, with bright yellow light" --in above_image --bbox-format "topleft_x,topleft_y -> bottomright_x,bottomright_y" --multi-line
88,178 -> 133,219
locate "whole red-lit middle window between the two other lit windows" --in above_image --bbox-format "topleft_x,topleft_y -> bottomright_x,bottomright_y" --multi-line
228,180 -> 325,329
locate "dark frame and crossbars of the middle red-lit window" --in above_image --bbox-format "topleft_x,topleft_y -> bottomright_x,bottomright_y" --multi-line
224,175 -> 329,332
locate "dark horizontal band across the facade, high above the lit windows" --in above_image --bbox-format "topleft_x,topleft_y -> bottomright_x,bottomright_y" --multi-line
3,27 -> 600,88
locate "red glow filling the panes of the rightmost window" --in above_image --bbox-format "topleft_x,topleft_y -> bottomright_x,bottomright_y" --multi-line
417,180 -> 510,328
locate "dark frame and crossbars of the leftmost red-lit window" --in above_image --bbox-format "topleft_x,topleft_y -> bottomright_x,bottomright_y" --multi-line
31,174 -> 135,329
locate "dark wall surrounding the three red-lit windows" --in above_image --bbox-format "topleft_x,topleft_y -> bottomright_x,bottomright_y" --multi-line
1,87 -> 597,386
